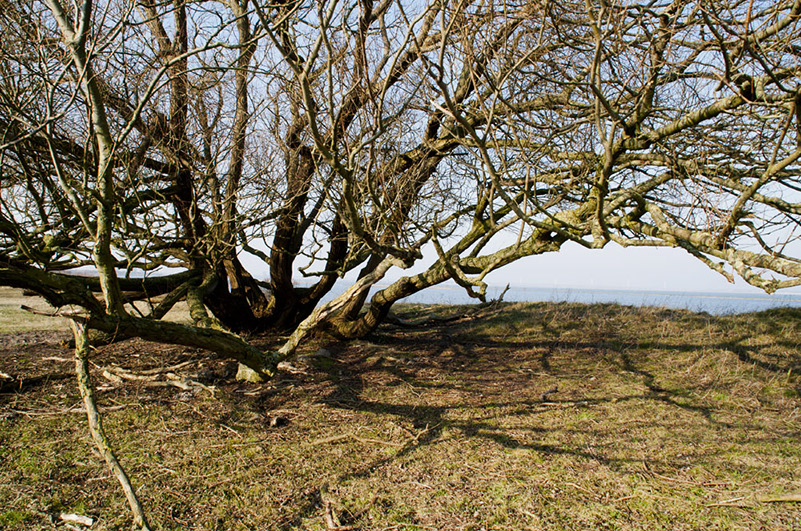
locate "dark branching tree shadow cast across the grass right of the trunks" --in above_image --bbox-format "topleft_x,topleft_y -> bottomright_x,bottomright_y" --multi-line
274,307 -> 801,529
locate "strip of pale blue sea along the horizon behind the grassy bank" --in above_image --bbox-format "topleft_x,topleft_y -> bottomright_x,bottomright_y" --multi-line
320,284 -> 801,315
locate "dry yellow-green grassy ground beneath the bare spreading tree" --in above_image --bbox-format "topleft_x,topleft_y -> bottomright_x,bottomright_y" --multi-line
0,291 -> 801,531
